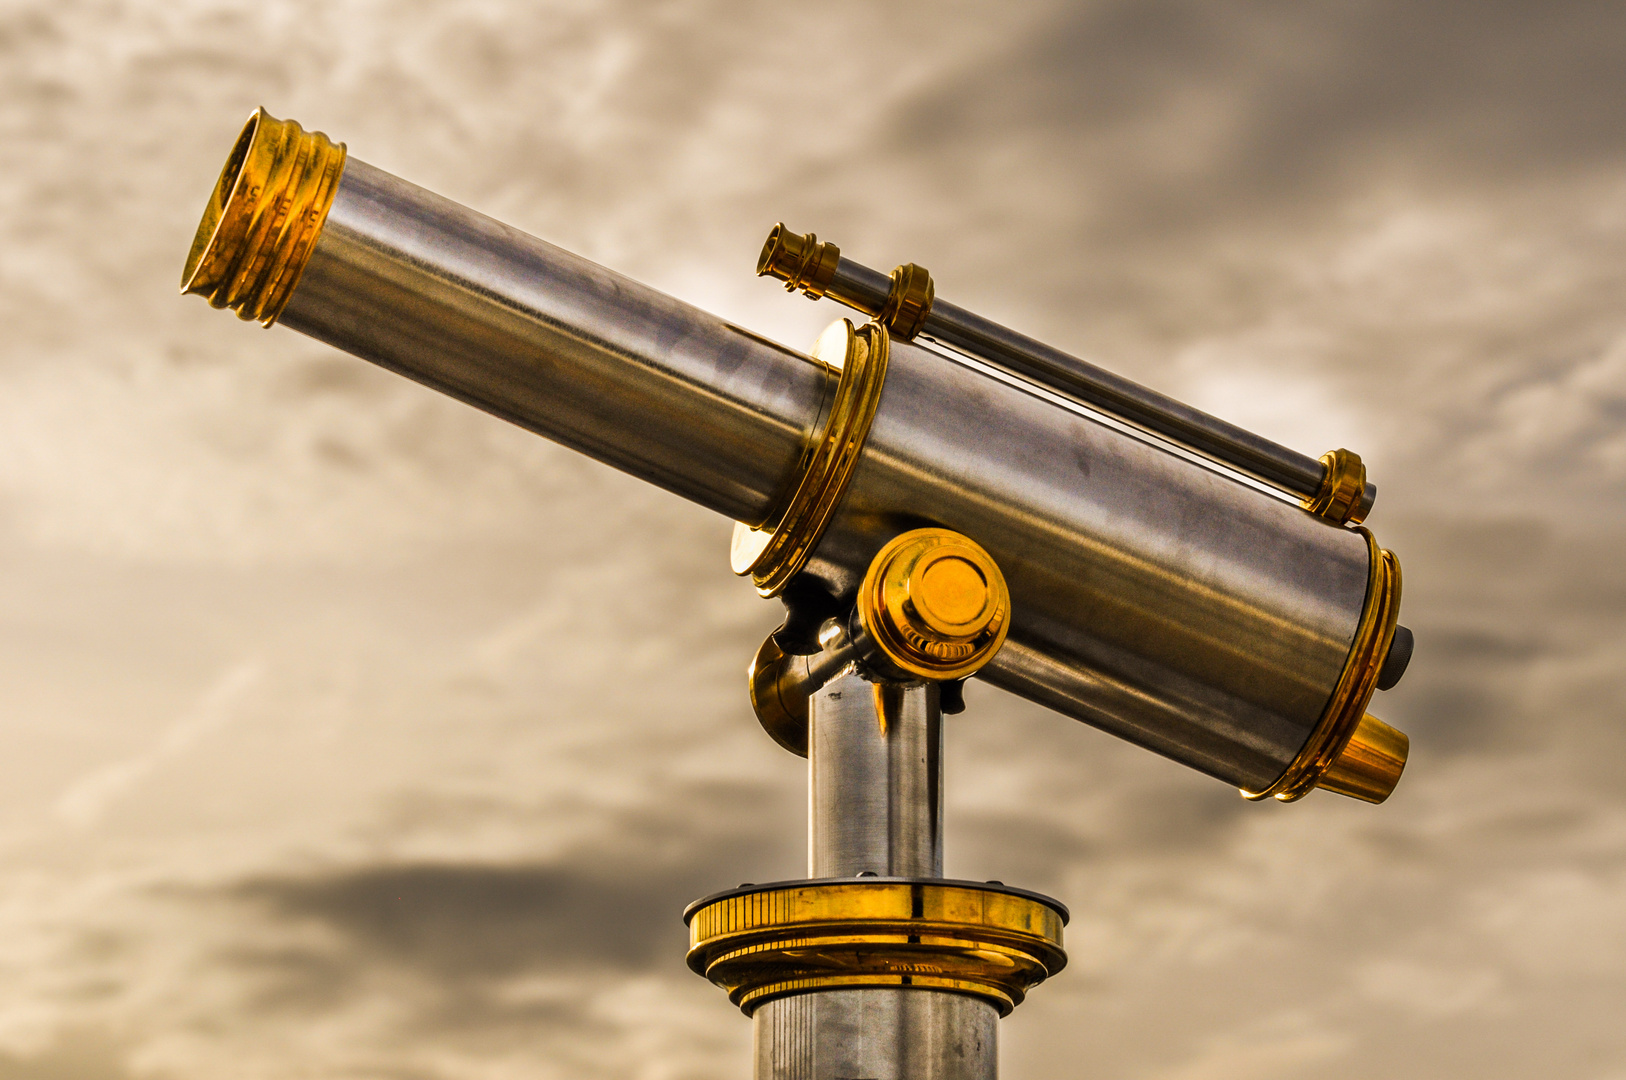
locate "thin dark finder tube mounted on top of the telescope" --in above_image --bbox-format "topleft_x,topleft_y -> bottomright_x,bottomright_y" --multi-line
758,224 -> 1377,520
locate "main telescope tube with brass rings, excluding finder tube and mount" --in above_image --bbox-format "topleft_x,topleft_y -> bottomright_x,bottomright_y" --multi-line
184,112 -> 1405,802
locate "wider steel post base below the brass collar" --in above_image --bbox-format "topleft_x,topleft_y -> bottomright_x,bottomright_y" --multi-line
751,987 -> 998,1080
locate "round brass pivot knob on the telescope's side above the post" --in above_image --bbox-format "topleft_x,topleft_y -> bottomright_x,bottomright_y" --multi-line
859,529 -> 1011,680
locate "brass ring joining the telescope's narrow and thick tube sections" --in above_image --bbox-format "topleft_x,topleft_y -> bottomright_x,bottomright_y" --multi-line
728,319 -> 888,597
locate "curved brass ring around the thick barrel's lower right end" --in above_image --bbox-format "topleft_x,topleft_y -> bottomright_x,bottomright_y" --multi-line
1242,529 -> 1403,802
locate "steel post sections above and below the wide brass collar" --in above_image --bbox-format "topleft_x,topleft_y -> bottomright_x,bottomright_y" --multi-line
753,667 -> 998,1080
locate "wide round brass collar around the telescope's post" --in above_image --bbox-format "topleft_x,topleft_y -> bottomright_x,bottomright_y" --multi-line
685,878 -> 1067,1017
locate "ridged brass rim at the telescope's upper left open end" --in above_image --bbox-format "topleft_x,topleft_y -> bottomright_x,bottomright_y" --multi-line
180,109 -> 345,327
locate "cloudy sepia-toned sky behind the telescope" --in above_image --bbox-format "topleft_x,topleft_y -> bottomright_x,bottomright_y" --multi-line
0,0 -> 1626,1080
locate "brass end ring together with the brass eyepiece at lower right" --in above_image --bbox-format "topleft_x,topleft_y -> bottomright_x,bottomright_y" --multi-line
1242,529 -> 1411,802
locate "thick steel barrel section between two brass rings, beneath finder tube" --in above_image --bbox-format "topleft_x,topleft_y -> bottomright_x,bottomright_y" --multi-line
808,342 -> 1371,790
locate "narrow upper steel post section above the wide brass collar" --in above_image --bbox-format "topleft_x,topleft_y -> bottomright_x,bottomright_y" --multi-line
808,667 -> 943,878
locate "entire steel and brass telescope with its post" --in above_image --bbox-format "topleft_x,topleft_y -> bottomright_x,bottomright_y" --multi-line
182,109 -> 1411,1080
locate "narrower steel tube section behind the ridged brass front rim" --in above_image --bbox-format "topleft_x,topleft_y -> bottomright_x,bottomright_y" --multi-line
281,158 -> 834,524
